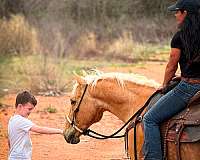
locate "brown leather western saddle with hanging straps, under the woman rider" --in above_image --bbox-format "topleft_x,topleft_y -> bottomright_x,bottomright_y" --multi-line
125,79 -> 200,160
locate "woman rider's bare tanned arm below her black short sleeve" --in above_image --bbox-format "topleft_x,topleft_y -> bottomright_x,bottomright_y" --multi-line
162,48 -> 181,87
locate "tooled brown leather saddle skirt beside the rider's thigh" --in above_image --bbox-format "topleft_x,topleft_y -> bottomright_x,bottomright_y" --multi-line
147,91 -> 200,143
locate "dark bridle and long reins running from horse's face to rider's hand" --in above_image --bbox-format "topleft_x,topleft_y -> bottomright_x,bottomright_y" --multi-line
65,84 -> 157,139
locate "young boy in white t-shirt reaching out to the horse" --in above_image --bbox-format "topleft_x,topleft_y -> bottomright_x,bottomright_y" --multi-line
8,91 -> 63,160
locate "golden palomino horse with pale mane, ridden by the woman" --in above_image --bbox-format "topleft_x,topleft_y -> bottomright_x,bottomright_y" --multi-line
64,73 -> 200,160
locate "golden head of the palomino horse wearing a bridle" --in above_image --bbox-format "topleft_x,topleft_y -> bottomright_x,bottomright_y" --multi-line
64,75 -> 104,144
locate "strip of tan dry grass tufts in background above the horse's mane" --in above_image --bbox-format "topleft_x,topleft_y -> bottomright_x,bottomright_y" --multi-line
67,31 -> 168,63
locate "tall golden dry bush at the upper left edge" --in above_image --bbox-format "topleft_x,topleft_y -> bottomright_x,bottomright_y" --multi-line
0,15 -> 39,54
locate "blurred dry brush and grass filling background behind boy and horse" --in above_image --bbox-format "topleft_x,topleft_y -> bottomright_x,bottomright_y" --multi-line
0,0 -> 176,92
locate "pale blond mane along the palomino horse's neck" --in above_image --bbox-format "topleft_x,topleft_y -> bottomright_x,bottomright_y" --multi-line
83,72 -> 160,88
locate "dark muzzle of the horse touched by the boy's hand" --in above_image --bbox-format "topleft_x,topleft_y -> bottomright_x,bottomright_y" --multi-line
64,127 -> 80,144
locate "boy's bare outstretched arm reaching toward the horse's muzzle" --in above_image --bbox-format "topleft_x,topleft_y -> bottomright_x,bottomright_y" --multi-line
30,125 -> 63,134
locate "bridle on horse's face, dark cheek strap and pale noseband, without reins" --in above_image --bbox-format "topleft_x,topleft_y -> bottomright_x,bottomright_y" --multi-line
66,84 -> 88,134
